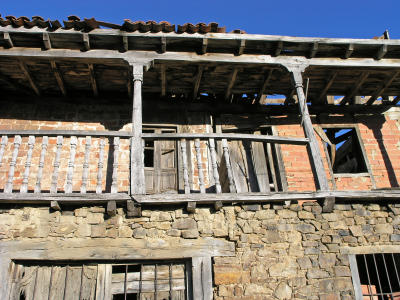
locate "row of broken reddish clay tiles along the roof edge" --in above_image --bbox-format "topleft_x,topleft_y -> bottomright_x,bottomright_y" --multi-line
0,15 -> 245,34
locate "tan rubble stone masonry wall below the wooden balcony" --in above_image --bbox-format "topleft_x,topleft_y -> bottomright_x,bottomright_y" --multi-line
0,202 -> 400,300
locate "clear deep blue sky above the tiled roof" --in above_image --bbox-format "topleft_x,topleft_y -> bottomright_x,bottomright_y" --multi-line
0,0 -> 400,39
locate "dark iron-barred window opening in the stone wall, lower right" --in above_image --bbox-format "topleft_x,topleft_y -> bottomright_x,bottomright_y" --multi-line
356,253 -> 400,300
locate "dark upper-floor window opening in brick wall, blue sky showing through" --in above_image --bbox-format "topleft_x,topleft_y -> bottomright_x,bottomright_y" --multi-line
324,128 -> 368,174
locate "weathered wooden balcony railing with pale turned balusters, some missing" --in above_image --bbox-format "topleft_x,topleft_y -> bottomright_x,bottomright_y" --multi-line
0,130 -> 308,199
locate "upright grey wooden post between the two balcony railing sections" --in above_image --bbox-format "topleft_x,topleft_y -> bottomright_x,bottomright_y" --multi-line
131,64 -> 146,194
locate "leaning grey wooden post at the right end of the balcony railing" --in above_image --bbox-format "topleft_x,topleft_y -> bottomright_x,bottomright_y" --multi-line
286,65 -> 329,191
